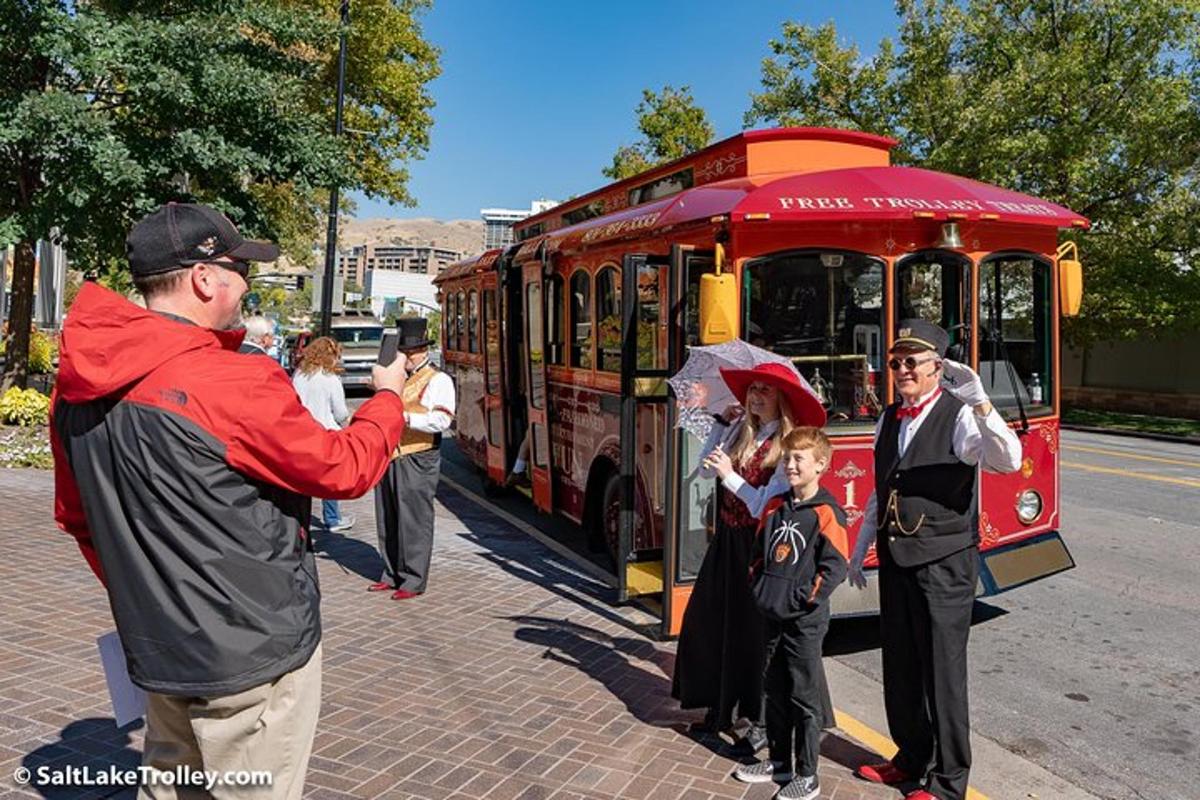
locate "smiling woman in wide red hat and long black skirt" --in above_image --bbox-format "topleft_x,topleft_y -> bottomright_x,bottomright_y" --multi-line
671,363 -> 826,754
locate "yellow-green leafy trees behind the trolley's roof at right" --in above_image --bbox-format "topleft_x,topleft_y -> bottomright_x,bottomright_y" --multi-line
746,0 -> 1200,343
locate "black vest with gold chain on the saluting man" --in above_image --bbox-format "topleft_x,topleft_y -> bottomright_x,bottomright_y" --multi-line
875,392 -> 979,567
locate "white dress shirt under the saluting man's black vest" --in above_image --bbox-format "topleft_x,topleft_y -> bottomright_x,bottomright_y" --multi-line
854,389 -> 1021,557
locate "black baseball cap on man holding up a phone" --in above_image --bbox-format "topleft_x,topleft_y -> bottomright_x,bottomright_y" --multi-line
125,203 -> 280,276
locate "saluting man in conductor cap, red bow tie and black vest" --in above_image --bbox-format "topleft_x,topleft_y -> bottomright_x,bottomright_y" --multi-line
850,319 -> 1021,800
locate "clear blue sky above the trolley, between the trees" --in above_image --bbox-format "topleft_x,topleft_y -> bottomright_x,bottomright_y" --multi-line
354,0 -> 896,219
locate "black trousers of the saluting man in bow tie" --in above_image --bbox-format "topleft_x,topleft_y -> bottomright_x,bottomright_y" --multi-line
880,547 -> 979,800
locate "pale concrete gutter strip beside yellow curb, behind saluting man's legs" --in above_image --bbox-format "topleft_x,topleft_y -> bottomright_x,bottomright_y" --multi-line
824,658 -> 1098,800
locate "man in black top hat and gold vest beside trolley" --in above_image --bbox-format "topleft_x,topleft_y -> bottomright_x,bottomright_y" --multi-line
367,317 -> 455,600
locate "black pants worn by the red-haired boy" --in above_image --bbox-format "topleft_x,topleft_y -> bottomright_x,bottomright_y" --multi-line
763,606 -> 829,776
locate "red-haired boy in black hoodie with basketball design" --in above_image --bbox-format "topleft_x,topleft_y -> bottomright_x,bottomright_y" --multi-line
734,427 -> 848,800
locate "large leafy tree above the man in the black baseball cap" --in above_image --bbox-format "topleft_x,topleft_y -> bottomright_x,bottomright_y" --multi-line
0,0 -> 438,385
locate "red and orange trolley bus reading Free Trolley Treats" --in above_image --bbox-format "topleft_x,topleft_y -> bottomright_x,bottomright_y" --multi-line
436,128 -> 1088,634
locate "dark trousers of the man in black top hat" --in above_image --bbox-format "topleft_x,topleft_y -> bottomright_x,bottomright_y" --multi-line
374,450 -> 442,591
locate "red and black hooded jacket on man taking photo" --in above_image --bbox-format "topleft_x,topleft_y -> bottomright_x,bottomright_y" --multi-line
50,283 -> 404,697
